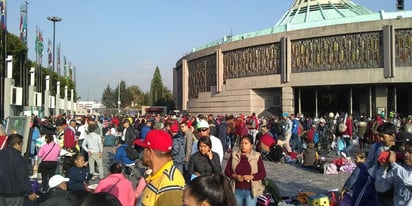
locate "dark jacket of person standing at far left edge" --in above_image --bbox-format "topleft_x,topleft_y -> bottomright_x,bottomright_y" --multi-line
0,146 -> 33,197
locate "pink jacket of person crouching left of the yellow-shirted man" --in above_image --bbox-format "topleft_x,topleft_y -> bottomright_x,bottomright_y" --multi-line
94,174 -> 135,206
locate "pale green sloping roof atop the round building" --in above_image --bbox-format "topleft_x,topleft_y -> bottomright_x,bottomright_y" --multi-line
191,0 -> 412,52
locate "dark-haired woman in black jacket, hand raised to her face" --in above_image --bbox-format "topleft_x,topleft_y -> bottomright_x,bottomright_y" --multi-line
187,137 -> 222,179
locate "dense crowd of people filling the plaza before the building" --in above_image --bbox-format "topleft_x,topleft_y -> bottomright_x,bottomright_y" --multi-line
0,113 -> 412,206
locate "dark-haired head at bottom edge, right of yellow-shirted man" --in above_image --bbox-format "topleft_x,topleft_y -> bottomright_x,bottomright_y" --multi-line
183,173 -> 236,206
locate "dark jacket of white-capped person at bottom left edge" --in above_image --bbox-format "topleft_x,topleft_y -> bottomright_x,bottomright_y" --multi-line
39,188 -> 79,206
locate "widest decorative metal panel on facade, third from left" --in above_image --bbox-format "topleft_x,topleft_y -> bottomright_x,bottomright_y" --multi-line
291,32 -> 383,73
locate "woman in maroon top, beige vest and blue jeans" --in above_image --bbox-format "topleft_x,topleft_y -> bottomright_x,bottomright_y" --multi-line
225,135 -> 266,206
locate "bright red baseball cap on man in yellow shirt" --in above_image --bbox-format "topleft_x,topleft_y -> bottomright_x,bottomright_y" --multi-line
134,129 -> 173,152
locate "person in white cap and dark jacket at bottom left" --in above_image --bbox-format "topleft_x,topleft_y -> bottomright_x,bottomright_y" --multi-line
39,175 -> 79,206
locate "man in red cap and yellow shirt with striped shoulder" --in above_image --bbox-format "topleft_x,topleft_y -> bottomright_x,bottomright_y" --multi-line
135,130 -> 185,206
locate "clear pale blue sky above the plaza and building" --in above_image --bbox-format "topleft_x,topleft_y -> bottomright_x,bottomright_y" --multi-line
6,0 -> 412,101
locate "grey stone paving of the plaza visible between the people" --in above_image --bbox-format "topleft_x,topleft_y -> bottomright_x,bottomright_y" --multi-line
96,144 -> 358,197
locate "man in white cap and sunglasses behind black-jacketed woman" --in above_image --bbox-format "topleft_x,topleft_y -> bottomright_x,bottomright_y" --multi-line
192,120 -> 224,164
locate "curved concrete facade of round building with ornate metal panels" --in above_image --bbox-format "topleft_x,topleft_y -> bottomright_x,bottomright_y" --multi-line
174,2 -> 412,116
